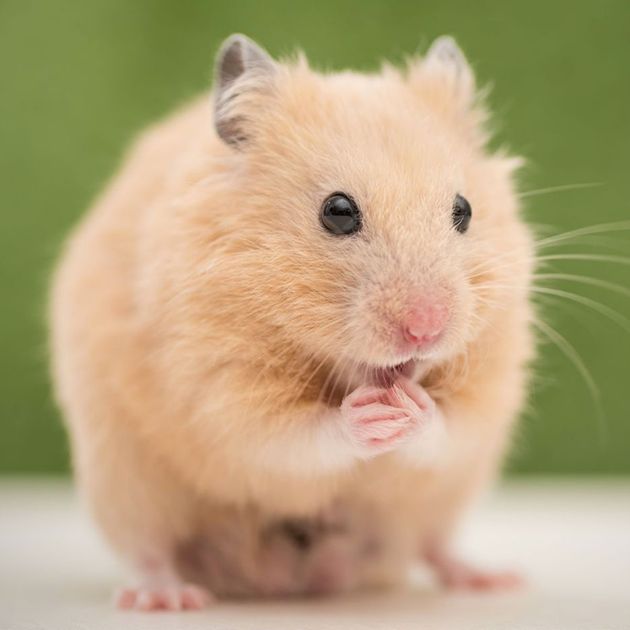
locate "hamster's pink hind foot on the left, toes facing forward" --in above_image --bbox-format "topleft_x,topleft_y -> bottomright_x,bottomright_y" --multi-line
116,583 -> 212,612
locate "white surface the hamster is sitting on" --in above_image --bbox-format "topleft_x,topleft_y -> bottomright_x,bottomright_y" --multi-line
0,481 -> 630,630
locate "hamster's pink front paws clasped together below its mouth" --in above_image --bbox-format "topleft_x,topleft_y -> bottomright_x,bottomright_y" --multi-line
341,379 -> 435,458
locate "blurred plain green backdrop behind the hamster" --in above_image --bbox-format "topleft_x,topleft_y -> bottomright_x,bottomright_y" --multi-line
0,0 -> 630,473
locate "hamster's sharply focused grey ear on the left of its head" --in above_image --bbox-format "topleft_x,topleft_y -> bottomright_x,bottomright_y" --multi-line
214,34 -> 278,146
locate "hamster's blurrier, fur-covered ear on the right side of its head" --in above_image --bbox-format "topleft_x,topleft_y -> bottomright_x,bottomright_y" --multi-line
408,35 -> 486,142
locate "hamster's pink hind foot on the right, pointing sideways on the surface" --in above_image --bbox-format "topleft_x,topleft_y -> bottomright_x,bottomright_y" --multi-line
426,552 -> 524,591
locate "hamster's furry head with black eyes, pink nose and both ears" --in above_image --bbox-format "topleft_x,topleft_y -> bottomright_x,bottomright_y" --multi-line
202,35 -> 532,388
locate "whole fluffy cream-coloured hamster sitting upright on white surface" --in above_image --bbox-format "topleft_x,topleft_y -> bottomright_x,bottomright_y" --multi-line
50,35 -> 535,610
